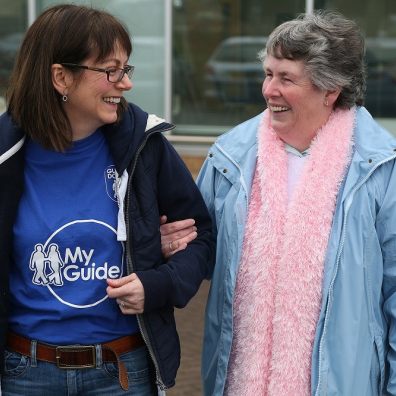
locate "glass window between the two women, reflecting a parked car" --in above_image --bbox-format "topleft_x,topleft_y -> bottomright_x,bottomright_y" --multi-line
172,0 -> 305,135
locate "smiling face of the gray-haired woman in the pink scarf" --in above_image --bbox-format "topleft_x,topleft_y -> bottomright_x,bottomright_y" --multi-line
262,55 -> 338,150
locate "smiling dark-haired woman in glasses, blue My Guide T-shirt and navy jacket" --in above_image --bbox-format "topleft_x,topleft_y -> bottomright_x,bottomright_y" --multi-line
0,5 -> 213,396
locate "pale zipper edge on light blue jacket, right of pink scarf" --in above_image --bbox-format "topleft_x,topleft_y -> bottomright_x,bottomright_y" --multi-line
315,155 -> 396,396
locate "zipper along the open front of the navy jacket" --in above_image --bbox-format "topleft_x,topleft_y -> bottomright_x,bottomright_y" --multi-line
125,124 -> 173,390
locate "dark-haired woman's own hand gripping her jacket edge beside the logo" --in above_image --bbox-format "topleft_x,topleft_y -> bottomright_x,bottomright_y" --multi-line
106,274 -> 144,315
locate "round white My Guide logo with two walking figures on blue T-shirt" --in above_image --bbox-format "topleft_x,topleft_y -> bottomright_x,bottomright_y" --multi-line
29,219 -> 124,308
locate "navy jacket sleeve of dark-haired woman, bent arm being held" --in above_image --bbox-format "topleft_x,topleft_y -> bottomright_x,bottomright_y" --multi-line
136,135 -> 215,312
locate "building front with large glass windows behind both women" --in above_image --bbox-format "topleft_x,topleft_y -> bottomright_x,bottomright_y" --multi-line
0,0 -> 396,146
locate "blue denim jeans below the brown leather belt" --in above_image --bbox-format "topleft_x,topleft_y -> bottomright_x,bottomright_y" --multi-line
1,346 -> 158,396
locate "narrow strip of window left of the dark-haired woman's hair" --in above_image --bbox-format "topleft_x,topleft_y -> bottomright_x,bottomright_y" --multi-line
0,0 -> 27,114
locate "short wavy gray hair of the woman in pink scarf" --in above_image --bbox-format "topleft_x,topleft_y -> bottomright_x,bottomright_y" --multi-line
259,10 -> 366,108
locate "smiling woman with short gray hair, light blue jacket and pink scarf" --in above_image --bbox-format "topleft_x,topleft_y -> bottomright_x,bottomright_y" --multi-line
162,12 -> 396,396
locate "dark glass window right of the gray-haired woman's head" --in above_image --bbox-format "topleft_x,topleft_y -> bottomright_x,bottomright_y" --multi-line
315,0 -> 396,133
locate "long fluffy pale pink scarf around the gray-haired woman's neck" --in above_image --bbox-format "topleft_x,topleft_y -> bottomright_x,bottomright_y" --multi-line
225,109 -> 355,396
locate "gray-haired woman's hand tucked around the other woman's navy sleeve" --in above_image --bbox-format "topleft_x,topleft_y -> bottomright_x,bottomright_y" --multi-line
160,216 -> 198,258
